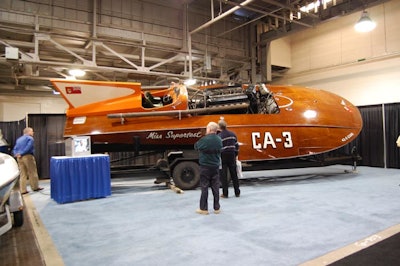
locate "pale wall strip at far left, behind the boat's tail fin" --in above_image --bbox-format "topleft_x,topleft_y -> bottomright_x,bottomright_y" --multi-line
0,95 -> 68,122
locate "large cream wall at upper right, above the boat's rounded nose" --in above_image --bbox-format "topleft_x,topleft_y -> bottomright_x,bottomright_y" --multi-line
274,0 -> 400,106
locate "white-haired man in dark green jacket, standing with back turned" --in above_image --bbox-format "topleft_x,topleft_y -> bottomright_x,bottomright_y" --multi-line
194,122 -> 222,215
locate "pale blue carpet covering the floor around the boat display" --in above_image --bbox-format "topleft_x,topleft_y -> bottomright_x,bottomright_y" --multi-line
30,165 -> 400,266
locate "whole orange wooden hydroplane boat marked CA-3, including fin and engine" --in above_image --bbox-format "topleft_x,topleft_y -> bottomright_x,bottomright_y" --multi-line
52,80 -> 362,187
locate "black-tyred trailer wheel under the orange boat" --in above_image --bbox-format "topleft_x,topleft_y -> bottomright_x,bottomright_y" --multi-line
172,161 -> 200,189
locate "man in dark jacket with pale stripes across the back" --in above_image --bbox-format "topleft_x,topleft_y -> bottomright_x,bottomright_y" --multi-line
218,119 -> 240,198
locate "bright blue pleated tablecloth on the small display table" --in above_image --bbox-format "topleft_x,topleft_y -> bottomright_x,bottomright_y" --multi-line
50,154 -> 111,203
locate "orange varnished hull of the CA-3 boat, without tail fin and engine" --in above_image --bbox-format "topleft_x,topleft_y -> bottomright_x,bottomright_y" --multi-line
52,81 -> 362,161
